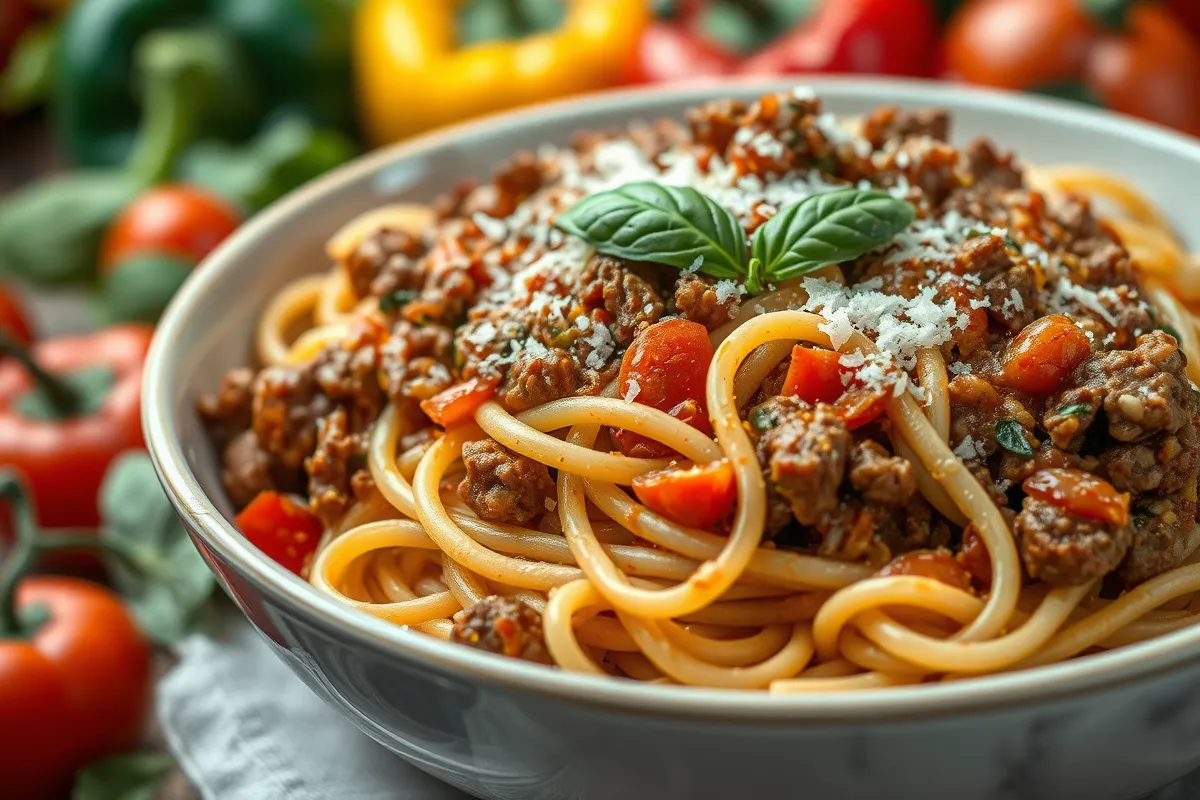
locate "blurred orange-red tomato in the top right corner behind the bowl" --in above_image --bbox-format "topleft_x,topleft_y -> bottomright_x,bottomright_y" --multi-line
1084,2 -> 1200,136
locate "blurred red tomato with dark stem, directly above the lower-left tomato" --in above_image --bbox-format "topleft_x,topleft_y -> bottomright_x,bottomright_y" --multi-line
0,325 -> 154,529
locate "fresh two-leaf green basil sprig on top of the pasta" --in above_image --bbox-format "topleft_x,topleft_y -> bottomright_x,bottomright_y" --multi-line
556,182 -> 916,294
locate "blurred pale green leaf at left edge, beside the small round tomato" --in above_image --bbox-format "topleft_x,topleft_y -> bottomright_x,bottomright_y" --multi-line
0,170 -> 140,284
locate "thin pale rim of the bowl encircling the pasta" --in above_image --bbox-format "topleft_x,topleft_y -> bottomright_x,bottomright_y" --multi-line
142,76 -> 1200,723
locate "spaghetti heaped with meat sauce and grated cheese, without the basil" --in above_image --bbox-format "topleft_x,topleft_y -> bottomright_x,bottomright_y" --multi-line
200,90 -> 1200,692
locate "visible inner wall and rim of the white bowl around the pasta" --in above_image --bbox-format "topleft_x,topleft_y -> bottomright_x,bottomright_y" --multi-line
144,78 -> 1200,717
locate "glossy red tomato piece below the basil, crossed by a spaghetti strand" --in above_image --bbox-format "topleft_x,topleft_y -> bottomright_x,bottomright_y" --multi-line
612,319 -> 713,458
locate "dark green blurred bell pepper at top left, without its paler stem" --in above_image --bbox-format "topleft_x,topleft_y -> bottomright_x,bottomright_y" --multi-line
52,0 -> 355,167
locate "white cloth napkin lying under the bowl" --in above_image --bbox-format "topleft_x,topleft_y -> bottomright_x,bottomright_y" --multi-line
158,619 -> 1200,800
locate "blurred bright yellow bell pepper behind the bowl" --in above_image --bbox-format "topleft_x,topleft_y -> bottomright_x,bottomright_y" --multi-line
354,0 -> 650,144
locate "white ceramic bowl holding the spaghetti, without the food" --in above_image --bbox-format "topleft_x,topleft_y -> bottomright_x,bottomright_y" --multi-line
144,78 -> 1200,800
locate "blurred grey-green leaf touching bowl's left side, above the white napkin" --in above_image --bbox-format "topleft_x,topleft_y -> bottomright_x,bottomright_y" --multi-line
100,451 -> 214,646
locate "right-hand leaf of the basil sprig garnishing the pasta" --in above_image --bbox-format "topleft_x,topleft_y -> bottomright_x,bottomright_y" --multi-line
751,188 -> 917,281
